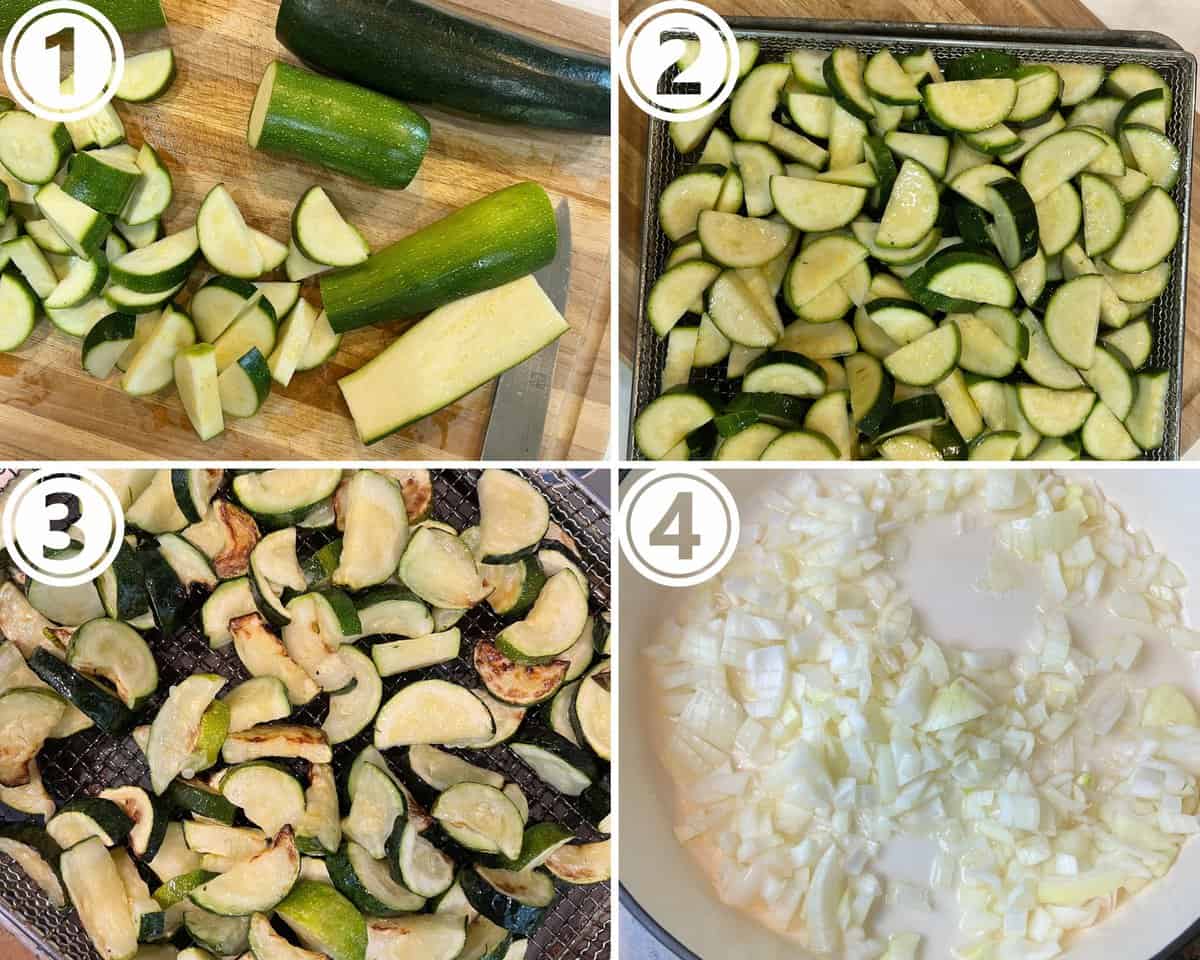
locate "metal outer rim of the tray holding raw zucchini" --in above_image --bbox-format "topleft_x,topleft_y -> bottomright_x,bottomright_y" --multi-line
626,17 -> 1198,461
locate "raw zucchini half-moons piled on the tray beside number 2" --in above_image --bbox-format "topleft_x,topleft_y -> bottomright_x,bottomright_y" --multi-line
634,43 -> 1184,461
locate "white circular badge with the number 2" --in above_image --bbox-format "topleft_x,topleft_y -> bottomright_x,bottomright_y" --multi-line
617,0 -> 740,121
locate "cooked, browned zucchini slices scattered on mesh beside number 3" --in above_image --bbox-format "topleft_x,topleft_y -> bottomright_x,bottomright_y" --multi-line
0,468 -> 612,960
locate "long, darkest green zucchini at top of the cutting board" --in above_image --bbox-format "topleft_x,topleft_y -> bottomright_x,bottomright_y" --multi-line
275,0 -> 612,133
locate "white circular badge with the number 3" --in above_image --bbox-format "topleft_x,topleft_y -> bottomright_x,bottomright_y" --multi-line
0,468 -> 125,587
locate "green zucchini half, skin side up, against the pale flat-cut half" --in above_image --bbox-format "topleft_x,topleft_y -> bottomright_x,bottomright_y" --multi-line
320,182 -> 558,334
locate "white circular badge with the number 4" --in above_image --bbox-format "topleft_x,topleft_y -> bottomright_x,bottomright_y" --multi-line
620,472 -> 740,587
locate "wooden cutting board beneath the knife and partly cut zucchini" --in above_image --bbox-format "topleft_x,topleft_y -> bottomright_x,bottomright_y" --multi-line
0,0 -> 611,461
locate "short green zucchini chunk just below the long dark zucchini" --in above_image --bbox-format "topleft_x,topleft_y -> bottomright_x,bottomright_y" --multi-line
251,62 -> 430,190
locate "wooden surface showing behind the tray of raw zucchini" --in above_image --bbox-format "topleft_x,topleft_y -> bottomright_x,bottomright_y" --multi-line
619,0 -> 1200,452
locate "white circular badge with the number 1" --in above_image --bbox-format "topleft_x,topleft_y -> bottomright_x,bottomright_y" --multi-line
4,0 -> 125,124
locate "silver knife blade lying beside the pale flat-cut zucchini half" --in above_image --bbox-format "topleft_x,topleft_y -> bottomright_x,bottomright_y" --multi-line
481,200 -> 571,460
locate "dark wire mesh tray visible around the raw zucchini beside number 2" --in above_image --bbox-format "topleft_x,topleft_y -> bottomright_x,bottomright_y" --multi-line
628,17 -> 1196,460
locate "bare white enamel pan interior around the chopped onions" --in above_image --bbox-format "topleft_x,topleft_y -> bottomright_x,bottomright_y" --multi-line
619,466 -> 1200,960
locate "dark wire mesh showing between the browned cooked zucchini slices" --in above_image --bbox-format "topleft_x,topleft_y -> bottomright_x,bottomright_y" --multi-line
0,470 -> 612,960
